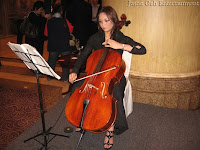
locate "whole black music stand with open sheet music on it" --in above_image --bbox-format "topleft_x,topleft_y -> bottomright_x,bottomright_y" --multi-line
8,42 -> 69,150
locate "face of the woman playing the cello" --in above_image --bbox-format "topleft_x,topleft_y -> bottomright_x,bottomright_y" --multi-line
99,12 -> 114,33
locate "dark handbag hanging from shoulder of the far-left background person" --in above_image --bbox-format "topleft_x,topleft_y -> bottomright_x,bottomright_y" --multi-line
20,13 -> 39,38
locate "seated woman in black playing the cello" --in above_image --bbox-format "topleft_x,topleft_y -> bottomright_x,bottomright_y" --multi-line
69,6 -> 146,149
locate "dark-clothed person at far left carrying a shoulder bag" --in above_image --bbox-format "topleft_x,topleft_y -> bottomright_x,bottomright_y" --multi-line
25,1 -> 47,56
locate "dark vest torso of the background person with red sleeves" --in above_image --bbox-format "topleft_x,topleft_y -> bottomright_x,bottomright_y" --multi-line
47,17 -> 71,52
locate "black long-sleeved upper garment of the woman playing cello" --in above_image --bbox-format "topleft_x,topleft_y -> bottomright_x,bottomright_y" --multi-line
73,31 -> 146,74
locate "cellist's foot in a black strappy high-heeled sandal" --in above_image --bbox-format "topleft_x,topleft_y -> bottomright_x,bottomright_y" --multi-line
104,126 -> 114,150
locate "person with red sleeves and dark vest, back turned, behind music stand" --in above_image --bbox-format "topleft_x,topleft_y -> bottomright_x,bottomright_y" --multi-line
45,4 -> 73,81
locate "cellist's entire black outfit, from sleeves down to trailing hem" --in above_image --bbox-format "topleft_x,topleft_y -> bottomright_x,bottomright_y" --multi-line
72,31 -> 146,134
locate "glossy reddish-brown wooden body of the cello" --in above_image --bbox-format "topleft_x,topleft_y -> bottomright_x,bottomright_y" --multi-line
65,48 -> 125,133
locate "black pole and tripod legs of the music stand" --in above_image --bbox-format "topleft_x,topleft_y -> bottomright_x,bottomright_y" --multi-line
24,70 -> 69,150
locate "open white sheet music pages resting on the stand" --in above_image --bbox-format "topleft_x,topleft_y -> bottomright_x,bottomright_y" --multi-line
8,42 -> 61,80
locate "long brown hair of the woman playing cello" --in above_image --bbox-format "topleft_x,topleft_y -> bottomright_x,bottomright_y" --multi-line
97,6 -> 119,38
